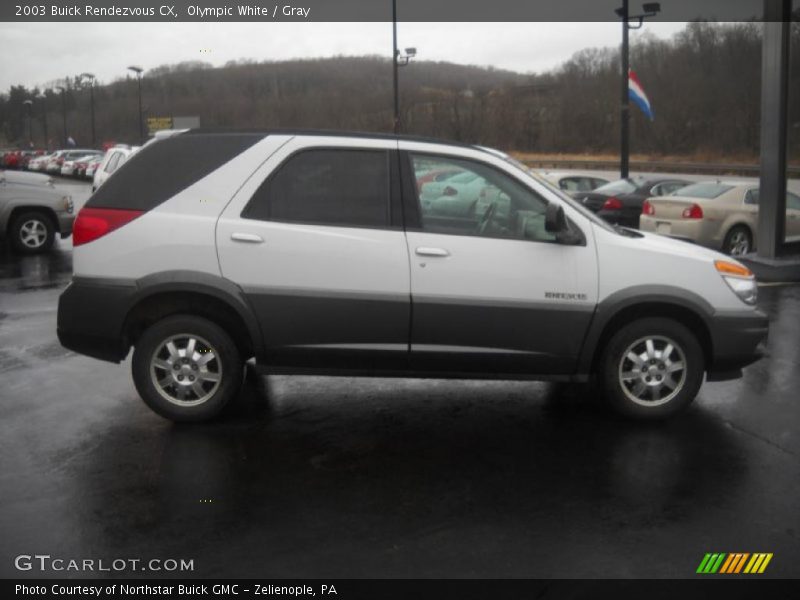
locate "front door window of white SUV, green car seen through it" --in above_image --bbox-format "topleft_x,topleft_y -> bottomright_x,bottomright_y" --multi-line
411,154 -> 555,241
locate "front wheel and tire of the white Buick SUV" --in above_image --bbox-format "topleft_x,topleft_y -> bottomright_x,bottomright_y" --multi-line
598,317 -> 705,419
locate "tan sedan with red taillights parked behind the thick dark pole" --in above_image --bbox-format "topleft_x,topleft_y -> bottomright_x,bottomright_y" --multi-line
639,181 -> 800,256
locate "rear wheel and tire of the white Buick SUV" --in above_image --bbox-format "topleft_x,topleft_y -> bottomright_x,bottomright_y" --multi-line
131,315 -> 244,422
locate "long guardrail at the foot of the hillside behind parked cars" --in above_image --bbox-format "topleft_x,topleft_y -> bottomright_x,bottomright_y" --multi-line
522,158 -> 800,178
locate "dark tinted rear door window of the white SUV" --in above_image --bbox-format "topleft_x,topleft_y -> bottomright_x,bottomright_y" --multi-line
242,149 -> 389,227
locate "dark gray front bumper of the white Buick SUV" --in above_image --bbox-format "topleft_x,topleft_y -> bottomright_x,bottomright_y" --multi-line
708,310 -> 769,380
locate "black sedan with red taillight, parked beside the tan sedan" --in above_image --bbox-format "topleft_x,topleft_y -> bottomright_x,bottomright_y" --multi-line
574,177 -> 690,229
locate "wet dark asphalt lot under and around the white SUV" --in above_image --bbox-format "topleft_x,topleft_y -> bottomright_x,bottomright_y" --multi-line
0,180 -> 800,578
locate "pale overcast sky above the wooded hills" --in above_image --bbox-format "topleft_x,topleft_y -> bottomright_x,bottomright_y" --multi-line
0,22 -> 685,92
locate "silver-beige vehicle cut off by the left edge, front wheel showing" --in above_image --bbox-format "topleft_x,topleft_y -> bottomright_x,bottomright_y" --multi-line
0,171 -> 75,254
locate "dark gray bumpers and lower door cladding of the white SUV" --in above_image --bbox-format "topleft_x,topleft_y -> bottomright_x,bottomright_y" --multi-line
58,278 -> 768,379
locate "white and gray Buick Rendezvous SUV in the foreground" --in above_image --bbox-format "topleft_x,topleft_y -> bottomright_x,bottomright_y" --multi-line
58,130 -> 767,421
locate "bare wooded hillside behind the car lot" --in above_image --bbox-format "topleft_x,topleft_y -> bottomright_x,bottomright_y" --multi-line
0,23 -> 800,161
